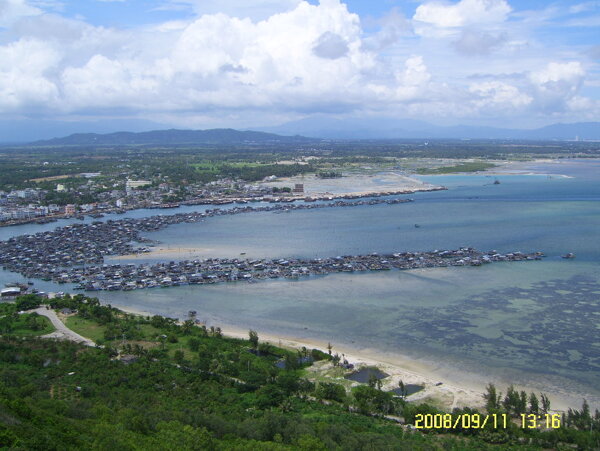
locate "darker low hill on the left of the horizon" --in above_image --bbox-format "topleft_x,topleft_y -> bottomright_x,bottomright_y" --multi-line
31,128 -> 314,146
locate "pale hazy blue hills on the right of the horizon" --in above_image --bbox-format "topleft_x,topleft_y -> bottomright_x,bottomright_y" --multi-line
259,116 -> 600,140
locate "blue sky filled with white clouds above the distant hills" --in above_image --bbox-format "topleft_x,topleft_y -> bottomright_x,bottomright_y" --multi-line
0,0 -> 600,141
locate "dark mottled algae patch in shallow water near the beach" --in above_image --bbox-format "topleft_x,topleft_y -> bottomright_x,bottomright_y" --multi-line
384,276 -> 600,383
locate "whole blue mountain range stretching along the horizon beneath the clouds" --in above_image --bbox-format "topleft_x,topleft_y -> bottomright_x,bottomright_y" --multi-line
14,117 -> 600,146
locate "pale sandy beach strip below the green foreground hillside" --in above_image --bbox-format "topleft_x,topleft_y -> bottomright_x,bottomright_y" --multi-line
113,305 -> 581,413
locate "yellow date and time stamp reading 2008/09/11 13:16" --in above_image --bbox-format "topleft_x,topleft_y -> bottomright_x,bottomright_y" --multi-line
415,413 -> 561,429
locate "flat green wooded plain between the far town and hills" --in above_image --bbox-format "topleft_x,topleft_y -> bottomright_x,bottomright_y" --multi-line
0,140 -> 600,192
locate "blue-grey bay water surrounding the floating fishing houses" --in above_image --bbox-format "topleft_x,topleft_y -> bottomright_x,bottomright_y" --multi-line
0,160 -> 600,406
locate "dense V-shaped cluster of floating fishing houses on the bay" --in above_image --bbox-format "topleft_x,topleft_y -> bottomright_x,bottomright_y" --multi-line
0,198 -> 543,291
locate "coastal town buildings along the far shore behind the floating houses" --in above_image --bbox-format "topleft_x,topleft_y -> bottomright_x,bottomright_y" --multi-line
0,170 -> 445,226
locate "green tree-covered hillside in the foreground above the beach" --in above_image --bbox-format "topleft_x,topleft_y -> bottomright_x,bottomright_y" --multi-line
0,295 -> 600,450
